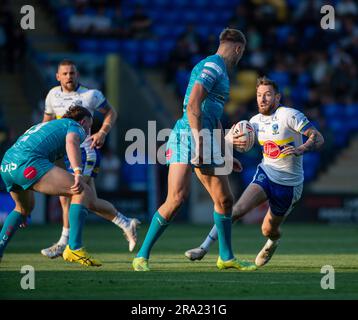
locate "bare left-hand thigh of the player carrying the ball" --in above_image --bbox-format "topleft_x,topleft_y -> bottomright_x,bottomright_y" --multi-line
233,183 -> 267,217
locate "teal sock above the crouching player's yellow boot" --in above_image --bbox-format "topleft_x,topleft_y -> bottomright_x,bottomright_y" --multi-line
68,204 -> 88,250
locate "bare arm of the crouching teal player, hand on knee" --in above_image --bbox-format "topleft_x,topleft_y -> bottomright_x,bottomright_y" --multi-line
66,132 -> 84,194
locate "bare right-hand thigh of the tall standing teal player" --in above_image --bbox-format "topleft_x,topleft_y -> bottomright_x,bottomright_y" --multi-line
195,168 -> 233,203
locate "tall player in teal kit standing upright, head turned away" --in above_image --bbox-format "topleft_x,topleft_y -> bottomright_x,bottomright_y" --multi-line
132,29 -> 256,271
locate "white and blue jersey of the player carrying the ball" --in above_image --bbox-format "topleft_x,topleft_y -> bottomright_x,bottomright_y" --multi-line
250,106 -> 312,186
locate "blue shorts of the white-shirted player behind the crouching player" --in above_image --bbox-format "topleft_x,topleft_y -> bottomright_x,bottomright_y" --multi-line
64,147 -> 102,178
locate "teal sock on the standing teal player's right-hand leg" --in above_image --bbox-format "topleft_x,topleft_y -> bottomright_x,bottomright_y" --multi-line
214,211 -> 234,261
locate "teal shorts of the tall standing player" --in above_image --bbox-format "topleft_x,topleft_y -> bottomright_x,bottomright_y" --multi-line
165,119 -> 224,167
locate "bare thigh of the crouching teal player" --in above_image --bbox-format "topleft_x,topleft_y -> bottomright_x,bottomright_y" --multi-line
32,166 -> 75,197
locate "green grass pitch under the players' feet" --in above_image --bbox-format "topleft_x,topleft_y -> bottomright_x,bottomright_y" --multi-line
0,223 -> 358,300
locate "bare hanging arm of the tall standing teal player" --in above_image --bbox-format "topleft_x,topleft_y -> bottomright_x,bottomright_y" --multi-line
187,83 -> 207,165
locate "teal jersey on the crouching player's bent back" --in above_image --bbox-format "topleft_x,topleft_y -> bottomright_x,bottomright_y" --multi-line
9,119 -> 86,162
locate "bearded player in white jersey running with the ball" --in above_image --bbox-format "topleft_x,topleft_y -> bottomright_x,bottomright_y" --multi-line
185,77 -> 324,266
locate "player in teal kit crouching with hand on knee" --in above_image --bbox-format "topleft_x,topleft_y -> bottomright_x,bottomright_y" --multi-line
0,106 -> 101,266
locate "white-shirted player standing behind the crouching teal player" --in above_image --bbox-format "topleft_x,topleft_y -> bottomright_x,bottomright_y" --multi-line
41,60 -> 139,258
